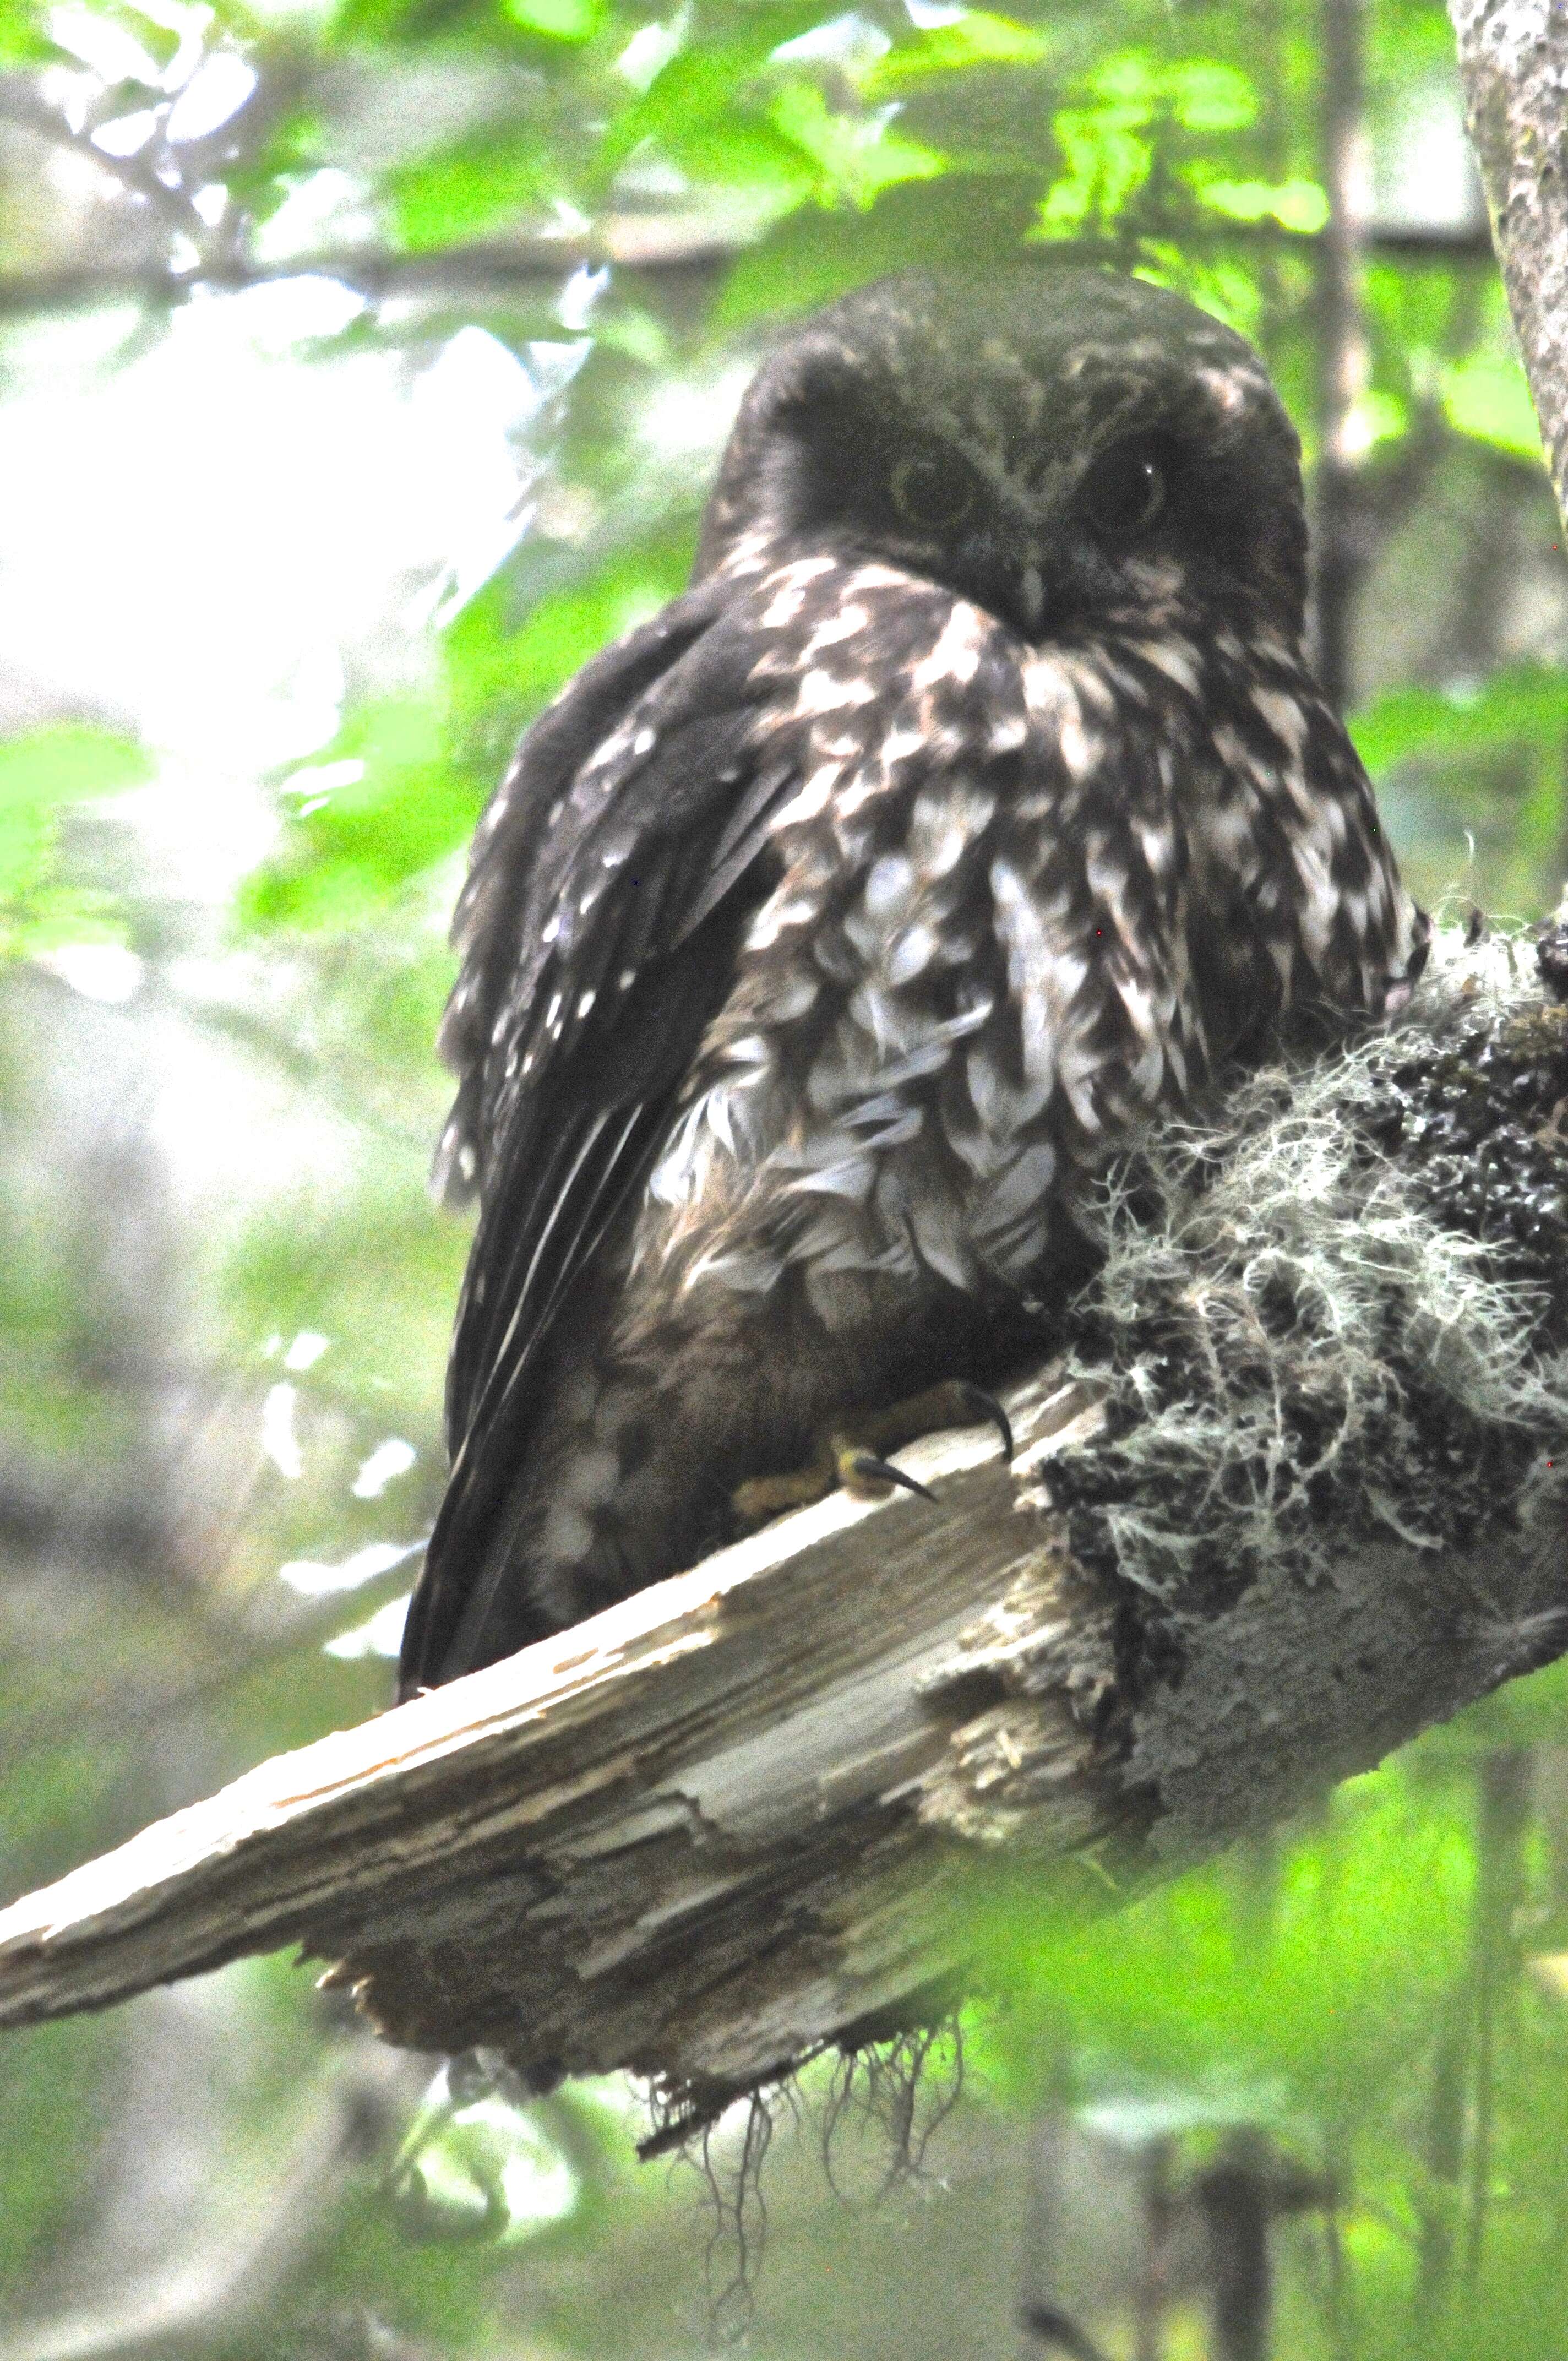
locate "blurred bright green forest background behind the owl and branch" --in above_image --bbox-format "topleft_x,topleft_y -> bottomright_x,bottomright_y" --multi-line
0,0 -> 1568,2361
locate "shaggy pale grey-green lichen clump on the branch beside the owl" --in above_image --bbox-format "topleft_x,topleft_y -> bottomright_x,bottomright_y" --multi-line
1051,933 -> 1568,1608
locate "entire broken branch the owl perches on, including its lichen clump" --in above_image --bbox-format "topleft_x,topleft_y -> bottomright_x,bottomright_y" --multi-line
0,951 -> 1568,2110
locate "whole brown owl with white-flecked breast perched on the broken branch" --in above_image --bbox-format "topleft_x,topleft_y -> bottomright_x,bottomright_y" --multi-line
404,271 -> 1427,1690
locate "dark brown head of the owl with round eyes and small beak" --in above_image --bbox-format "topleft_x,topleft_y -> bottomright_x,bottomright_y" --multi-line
696,269 -> 1306,645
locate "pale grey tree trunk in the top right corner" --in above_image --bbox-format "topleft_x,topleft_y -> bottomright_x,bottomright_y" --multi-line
1447,0 -> 1568,522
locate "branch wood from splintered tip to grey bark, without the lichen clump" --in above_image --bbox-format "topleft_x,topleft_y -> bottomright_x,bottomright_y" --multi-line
0,1265 -> 1568,2123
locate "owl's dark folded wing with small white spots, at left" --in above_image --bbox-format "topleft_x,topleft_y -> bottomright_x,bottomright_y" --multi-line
401,583 -> 796,1695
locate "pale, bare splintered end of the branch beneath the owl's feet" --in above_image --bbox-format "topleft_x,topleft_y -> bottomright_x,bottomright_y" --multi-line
0,1377 -> 1129,2087
